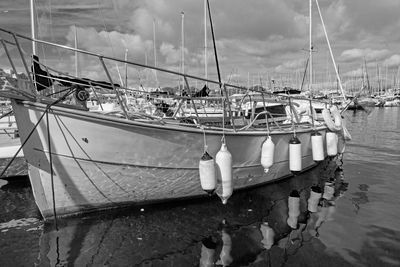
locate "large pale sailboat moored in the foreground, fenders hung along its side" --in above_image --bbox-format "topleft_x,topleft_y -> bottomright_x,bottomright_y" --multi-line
0,0 -> 344,220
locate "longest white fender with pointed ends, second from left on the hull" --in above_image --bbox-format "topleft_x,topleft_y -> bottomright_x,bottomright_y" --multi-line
215,143 -> 233,204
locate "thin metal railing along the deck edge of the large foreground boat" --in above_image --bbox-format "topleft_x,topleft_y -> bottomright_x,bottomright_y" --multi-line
0,28 -> 332,130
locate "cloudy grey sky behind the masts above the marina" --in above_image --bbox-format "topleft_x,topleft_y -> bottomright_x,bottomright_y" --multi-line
0,0 -> 400,90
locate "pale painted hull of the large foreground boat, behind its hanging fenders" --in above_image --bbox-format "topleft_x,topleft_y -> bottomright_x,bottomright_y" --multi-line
12,100 -> 326,220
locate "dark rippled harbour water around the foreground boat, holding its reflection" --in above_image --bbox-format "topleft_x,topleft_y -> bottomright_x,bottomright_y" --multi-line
0,108 -> 400,266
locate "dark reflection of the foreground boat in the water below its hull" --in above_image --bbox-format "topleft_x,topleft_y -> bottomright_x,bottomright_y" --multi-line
37,158 -> 346,266
